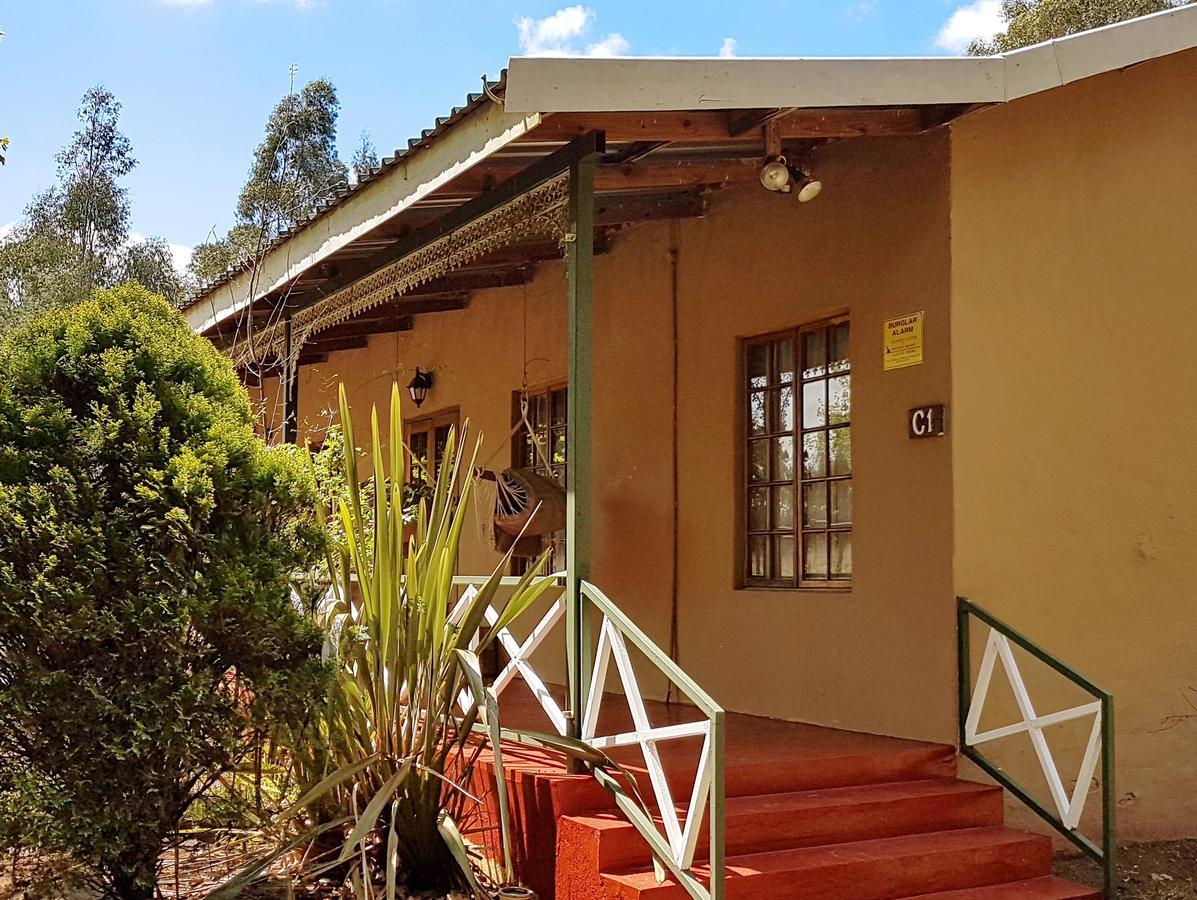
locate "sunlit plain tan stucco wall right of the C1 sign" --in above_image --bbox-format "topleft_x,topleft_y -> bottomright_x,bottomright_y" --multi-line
952,51 -> 1197,838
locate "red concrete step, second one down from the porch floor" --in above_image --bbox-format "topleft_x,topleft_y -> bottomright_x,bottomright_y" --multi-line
602,827 -> 1051,900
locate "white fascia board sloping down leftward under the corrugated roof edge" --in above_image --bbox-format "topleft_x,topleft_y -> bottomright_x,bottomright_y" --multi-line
184,103 -> 541,333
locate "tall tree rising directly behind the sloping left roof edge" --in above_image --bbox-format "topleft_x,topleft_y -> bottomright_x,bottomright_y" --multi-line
190,79 -> 348,282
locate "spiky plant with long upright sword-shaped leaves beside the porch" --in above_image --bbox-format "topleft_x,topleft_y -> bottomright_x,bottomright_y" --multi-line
288,385 -> 554,896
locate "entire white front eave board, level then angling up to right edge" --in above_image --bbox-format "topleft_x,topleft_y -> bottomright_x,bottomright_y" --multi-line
505,5 -> 1197,114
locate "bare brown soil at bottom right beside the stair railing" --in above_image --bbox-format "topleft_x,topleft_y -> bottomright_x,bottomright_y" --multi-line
1056,839 -> 1197,900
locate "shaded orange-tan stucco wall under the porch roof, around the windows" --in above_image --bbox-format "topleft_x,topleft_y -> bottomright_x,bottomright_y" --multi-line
292,133 -> 954,740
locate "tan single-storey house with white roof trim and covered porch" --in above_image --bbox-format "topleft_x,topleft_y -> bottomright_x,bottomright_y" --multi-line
186,7 -> 1197,896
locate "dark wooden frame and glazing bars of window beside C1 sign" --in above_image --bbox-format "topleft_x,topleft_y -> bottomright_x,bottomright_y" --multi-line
735,312 -> 856,591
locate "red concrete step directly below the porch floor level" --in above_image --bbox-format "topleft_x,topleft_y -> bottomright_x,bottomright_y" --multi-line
558,778 -> 1002,876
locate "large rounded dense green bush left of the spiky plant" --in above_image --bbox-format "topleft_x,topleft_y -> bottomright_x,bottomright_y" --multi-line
0,285 -> 326,900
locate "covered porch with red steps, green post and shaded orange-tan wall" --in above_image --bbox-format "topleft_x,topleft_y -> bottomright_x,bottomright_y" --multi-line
184,68 -> 1110,898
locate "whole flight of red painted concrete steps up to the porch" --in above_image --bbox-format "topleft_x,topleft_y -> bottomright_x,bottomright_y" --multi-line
469,716 -> 1101,900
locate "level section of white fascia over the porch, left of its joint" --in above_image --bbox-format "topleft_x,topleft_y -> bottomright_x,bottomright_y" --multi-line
505,56 -> 1003,113
